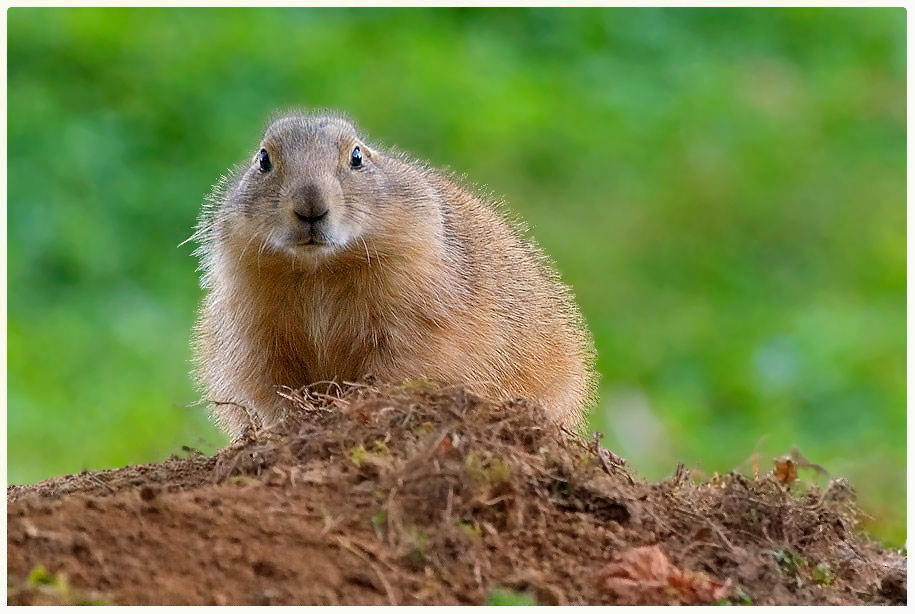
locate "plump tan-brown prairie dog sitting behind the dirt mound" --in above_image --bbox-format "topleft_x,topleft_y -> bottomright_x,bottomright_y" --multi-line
192,114 -> 596,439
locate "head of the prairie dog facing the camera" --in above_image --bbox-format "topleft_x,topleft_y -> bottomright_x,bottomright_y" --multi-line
218,115 -> 388,263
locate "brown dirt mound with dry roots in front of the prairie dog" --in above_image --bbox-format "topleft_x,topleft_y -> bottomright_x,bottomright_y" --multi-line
7,382 -> 906,605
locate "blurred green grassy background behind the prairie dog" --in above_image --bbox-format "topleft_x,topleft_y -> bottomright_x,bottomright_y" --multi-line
7,8 -> 906,544
